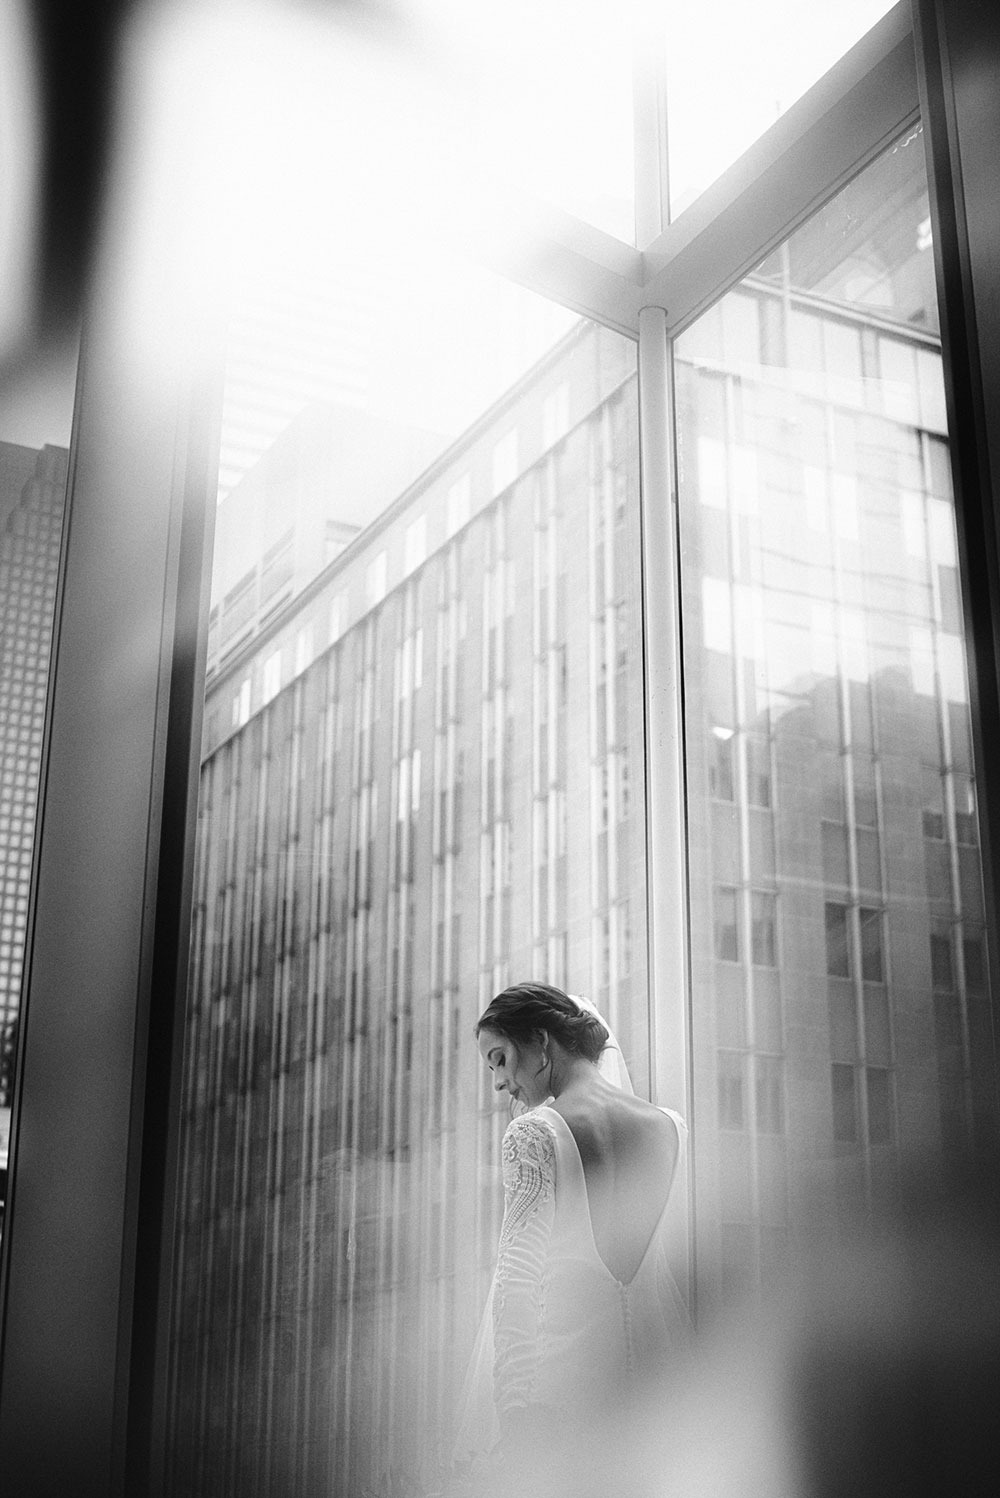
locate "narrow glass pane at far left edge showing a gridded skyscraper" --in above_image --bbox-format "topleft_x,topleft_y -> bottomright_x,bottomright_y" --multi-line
0,346 -> 76,1231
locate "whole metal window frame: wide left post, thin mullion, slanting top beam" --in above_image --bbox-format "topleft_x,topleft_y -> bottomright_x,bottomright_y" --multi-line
0,0 -> 1000,1498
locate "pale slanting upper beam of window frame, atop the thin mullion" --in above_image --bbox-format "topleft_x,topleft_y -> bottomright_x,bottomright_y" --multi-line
484,0 -> 919,340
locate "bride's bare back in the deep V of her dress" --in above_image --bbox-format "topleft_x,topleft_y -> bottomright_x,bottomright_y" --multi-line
552,1082 -> 680,1284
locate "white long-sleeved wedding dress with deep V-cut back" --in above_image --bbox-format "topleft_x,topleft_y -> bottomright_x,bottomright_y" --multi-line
455,1104 -> 689,1462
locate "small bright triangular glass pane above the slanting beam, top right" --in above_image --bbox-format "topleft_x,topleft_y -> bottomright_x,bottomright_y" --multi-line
663,0 -> 892,217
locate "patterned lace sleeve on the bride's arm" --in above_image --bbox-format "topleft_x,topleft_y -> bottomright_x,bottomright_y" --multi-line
493,1115 -> 555,1423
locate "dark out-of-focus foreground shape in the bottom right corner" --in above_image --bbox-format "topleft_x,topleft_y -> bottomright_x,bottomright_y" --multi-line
790,1159 -> 1000,1498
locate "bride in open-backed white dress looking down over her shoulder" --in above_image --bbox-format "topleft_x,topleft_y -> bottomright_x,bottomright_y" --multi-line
455,983 -> 687,1480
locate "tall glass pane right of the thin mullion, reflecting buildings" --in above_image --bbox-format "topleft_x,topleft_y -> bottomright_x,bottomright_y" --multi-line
675,135 -> 994,1308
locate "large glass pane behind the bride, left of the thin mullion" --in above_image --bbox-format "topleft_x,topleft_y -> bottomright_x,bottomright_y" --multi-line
172,38 -> 648,1498
